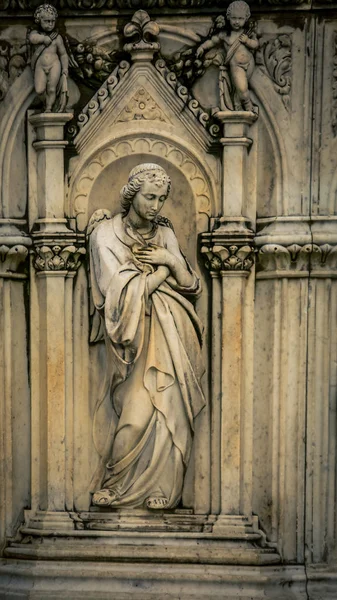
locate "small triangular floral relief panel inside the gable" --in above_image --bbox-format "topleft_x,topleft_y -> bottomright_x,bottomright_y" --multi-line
116,88 -> 170,123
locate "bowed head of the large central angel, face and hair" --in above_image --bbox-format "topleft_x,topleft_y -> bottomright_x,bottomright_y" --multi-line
121,163 -> 171,221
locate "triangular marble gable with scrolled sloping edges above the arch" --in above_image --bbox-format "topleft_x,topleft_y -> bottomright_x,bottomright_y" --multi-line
74,60 -> 219,151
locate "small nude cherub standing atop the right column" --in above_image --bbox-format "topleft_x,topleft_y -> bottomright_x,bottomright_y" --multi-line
195,0 -> 259,112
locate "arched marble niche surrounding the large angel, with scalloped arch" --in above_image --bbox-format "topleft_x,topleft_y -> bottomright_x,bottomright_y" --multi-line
66,129 -> 216,514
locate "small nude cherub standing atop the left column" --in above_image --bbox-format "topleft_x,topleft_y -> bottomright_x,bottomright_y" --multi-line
28,4 -> 69,112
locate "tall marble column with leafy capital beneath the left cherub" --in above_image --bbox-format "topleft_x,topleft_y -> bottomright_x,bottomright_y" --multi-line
27,113 -> 85,530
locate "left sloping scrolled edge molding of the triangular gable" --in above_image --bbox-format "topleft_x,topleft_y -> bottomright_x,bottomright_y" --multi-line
77,60 -> 131,132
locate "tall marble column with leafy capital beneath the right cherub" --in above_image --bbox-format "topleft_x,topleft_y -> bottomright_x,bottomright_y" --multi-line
201,111 -> 256,535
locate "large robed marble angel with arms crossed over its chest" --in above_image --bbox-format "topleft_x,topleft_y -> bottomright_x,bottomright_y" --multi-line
87,163 -> 205,510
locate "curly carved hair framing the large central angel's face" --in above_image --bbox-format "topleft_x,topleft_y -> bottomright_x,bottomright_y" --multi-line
120,163 -> 171,216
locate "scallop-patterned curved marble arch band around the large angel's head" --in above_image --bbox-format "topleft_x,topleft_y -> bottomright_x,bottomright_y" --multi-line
66,127 -> 216,230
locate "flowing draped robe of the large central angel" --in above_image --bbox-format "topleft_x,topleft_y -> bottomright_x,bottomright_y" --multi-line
90,215 -> 205,508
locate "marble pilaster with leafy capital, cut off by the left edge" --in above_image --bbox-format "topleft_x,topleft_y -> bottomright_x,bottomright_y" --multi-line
0,219 -> 32,548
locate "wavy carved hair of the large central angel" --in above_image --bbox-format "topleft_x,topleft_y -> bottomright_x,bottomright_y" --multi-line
120,163 -> 171,215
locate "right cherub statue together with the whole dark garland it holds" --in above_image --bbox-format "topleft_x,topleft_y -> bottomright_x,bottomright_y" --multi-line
172,0 -> 259,113
